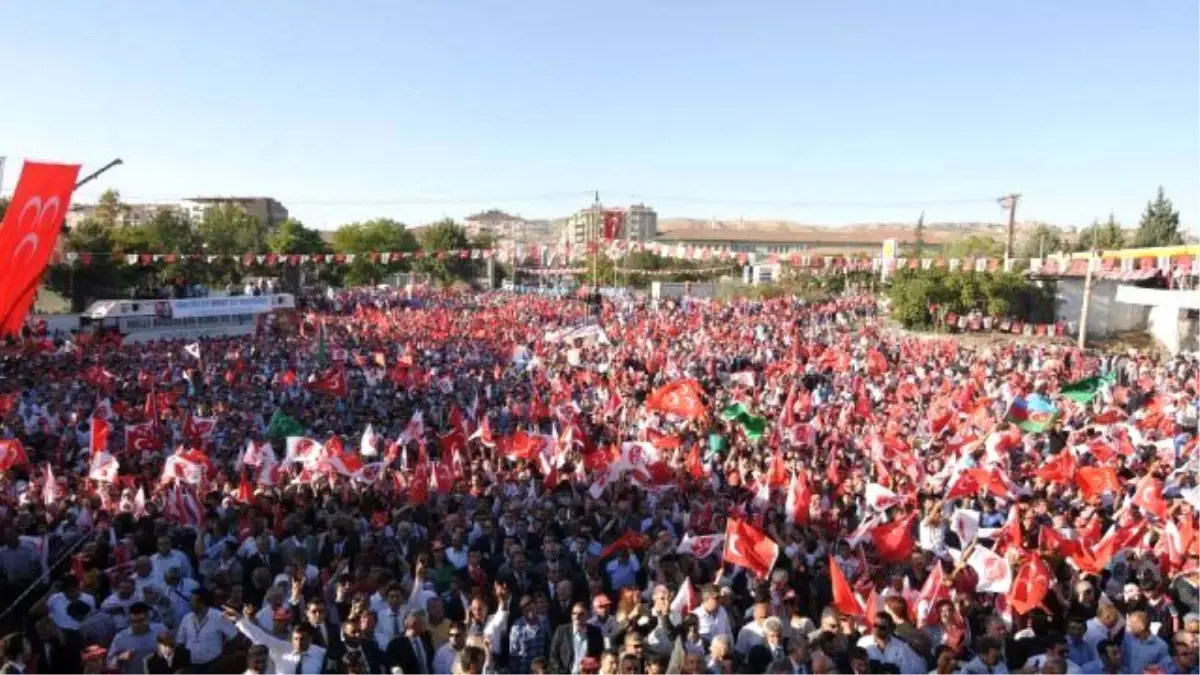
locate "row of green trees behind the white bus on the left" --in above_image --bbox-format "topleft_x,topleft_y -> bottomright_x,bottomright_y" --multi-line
0,191 -> 493,310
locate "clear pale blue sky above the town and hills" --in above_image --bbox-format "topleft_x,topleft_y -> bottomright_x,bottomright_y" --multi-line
0,0 -> 1200,228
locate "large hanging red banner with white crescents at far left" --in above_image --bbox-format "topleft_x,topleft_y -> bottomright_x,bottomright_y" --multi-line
0,162 -> 79,331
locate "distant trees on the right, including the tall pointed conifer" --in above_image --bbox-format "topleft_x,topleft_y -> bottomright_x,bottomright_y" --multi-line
908,187 -> 1184,258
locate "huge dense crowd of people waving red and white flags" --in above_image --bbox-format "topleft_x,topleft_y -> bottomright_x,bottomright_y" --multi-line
0,284 -> 1200,675
